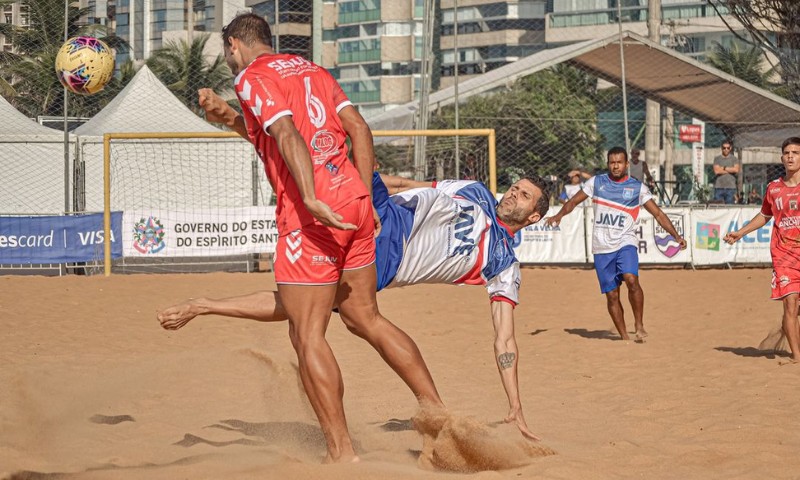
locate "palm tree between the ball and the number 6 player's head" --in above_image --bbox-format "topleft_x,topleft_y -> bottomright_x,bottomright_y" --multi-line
147,34 -> 232,114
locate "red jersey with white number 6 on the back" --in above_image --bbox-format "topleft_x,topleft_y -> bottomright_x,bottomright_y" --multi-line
234,54 -> 369,233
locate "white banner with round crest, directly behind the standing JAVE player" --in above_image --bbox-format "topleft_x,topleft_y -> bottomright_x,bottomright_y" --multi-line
586,208 -> 692,264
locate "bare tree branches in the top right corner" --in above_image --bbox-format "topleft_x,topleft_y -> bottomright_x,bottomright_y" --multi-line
707,0 -> 800,102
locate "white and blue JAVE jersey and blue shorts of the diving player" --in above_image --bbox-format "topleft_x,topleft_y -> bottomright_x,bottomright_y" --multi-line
372,174 -> 520,304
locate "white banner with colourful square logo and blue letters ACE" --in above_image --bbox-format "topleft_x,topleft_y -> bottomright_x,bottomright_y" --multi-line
692,207 -> 773,265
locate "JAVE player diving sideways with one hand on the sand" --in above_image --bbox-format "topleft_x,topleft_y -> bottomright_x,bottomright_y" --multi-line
158,174 -> 548,439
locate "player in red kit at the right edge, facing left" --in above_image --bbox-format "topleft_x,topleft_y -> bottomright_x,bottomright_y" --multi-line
724,137 -> 800,363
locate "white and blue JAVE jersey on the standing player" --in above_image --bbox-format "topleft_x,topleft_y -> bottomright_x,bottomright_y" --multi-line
583,174 -> 653,253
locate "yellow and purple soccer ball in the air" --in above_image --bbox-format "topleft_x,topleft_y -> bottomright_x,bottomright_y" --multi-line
56,37 -> 114,95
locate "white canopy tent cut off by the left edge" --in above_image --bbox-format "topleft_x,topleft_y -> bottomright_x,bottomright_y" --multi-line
0,97 -> 73,215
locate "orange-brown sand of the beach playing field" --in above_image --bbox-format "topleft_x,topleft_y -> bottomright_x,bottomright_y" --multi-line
0,268 -> 800,480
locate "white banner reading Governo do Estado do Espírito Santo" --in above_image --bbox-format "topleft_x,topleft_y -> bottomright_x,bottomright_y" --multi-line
122,206 -> 278,257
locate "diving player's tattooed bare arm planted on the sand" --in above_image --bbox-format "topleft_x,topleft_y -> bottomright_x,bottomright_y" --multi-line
492,301 -> 539,440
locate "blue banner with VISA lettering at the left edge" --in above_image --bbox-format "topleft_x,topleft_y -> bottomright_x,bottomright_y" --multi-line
0,212 -> 122,264
